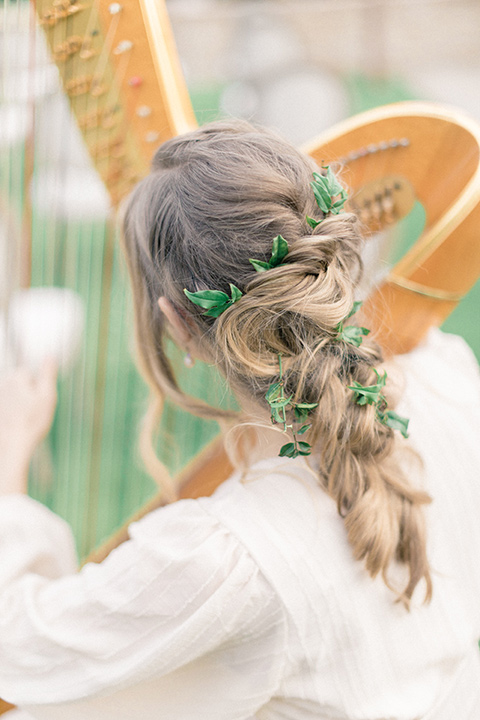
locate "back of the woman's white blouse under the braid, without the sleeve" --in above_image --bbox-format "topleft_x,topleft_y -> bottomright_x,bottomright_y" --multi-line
201,331 -> 480,720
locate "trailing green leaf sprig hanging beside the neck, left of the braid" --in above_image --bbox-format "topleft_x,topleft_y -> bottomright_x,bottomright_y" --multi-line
265,354 -> 318,458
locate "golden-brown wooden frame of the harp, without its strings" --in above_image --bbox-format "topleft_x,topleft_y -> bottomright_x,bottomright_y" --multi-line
0,0 -> 480,714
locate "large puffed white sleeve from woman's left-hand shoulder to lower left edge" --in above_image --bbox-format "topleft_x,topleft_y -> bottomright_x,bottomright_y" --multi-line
0,500 -> 286,719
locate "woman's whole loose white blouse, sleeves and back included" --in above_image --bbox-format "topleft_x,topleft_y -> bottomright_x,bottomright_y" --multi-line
0,331 -> 480,720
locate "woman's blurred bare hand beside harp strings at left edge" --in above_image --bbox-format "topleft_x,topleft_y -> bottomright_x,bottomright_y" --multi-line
0,362 -> 57,495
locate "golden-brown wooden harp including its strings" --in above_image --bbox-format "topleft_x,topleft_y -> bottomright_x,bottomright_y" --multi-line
0,0 -> 480,712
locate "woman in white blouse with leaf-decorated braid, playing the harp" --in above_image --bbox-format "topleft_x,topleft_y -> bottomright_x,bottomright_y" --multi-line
0,123 -> 480,720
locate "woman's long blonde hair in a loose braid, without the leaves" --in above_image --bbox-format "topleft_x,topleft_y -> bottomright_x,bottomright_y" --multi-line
124,121 -> 432,607
